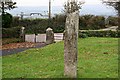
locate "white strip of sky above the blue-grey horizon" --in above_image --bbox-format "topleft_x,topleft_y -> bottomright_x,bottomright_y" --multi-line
13,0 -> 101,6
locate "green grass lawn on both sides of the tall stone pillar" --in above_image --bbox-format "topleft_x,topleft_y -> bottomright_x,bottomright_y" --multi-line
2,38 -> 118,78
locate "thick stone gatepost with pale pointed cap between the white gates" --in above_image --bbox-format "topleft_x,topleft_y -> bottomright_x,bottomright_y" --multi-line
46,28 -> 54,44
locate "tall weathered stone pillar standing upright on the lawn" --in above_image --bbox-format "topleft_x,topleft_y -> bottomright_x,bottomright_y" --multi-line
64,0 -> 79,78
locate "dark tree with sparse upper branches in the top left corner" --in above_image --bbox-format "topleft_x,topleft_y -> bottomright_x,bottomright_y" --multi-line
0,0 -> 16,28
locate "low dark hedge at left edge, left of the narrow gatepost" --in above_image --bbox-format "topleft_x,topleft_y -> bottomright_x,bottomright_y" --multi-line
2,27 -> 21,38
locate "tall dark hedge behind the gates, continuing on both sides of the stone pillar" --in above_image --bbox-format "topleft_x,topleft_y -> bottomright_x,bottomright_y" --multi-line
12,14 -> 108,34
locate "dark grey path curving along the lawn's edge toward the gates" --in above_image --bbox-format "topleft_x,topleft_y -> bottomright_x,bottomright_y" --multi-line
0,43 -> 46,56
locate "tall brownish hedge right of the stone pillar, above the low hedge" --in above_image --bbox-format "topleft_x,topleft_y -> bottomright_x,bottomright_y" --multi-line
79,15 -> 105,30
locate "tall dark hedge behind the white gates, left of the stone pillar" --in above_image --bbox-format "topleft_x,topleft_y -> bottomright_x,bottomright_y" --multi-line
13,15 -> 65,34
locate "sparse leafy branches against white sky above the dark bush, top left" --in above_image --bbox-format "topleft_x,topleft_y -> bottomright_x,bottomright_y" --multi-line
0,0 -> 16,14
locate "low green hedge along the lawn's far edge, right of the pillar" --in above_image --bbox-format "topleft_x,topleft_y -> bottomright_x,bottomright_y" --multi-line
79,30 -> 120,38
